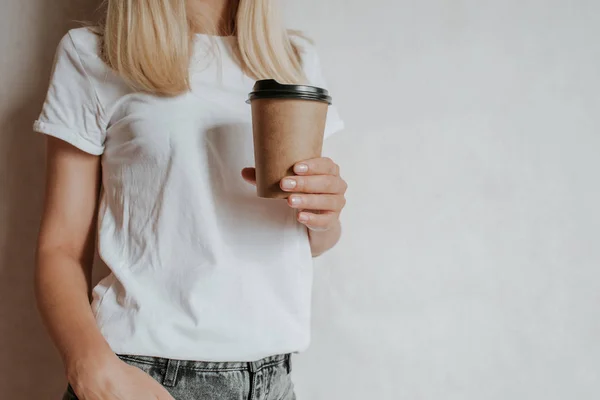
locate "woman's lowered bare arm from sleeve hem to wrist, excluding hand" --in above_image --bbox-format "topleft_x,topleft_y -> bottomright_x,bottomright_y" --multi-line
35,138 -> 112,373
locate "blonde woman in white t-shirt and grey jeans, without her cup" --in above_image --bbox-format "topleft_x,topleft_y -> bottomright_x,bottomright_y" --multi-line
35,0 -> 346,400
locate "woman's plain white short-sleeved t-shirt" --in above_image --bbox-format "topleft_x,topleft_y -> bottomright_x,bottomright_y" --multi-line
34,28 -> 343,361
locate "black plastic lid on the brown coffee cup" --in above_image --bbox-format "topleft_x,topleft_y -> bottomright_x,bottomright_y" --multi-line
246,79 -> 331,105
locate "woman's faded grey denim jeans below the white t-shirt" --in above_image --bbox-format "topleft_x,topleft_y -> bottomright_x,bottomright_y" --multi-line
63,354 -> 296,400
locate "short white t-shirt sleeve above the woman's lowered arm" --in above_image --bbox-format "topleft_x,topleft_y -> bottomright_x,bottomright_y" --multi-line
33,33 -> 106,155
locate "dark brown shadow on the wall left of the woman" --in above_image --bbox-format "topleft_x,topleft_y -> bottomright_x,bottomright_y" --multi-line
0,0 -> 99,400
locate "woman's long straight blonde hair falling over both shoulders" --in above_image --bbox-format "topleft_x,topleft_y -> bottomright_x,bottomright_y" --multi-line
101,0 -> 305,96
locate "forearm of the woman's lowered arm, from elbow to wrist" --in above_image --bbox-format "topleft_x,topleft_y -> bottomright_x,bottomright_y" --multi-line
35,250 -> 111,371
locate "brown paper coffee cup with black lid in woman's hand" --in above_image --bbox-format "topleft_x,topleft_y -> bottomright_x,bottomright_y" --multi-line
248,79 -> 331,199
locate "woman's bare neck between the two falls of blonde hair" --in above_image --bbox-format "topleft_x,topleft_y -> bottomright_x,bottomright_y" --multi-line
188,0 -> 238,36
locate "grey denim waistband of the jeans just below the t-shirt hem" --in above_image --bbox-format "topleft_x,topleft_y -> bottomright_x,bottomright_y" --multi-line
117,354 -> 291,372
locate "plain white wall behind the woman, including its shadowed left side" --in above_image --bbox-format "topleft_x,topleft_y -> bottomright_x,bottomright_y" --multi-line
0,0 -> 600,400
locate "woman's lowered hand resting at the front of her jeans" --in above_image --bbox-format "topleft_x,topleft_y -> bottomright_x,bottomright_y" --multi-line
67,354 -> 174,400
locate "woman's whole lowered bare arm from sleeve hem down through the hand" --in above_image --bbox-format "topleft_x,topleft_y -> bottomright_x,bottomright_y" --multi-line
35,138 -> 173,400
